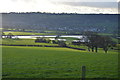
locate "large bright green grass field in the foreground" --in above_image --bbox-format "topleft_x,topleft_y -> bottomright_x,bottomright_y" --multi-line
2,46 -> 118,78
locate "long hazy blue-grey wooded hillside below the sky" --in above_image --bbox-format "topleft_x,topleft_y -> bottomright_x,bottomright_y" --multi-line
2,13 -> 118,33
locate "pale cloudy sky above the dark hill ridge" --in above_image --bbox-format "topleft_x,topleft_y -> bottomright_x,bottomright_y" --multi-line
0,0 -> 120,14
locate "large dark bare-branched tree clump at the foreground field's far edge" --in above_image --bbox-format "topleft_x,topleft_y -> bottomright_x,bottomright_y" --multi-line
85,31 -> 116,53
